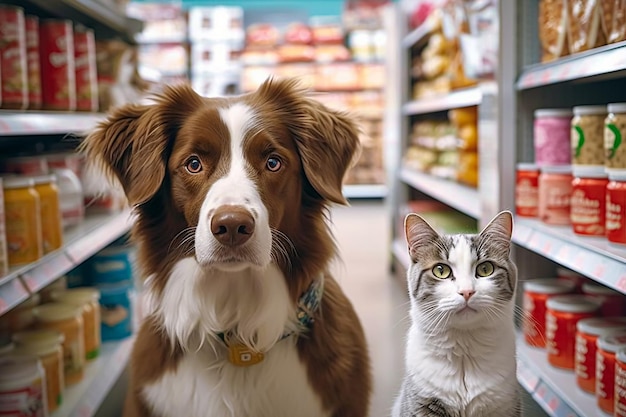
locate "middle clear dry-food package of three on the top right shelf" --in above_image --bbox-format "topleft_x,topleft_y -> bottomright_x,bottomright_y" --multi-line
566,0 -> 606,54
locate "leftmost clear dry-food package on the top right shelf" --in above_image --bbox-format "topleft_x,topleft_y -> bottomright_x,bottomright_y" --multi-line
539,0 -> 569,62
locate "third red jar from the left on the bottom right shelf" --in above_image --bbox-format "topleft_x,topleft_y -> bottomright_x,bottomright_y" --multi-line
574,317 -> 626,394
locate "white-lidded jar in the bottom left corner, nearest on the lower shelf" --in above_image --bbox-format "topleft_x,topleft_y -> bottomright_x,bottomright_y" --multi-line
0,356 -> 48,417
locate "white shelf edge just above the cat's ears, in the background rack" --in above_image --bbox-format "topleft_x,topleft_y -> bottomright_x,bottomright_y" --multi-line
400,168 -> 481,219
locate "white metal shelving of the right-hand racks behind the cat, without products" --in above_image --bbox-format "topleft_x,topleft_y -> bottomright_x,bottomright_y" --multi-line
390,0 -> 626,417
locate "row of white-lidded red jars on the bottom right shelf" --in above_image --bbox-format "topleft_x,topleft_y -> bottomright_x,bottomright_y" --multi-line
523,275 -> 626,416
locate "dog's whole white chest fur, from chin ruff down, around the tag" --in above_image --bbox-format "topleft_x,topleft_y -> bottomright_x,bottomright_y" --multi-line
142,258 -> 329,417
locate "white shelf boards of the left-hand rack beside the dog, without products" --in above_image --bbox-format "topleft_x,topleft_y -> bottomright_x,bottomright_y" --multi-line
0,0 -> 142,417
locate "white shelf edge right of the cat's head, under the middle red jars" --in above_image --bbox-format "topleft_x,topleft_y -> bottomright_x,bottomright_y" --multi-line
513,217 -> 626,293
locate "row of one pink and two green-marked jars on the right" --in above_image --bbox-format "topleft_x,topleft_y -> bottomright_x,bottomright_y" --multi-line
533,103 -> 626,173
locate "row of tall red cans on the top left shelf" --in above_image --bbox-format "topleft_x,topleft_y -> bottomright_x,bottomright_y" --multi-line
0,5 -> 98,112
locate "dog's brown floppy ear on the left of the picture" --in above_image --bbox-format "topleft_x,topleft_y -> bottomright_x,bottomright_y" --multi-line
80,85 -> 202,205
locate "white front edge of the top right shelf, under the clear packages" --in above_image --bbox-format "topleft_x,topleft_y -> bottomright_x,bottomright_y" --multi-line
517,42 -> 626,90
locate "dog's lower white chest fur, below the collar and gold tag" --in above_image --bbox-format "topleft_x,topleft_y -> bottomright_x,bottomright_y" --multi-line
143,338 -> 329,417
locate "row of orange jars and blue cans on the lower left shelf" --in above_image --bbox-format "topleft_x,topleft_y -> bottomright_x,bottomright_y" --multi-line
0,239 -> 138,416
